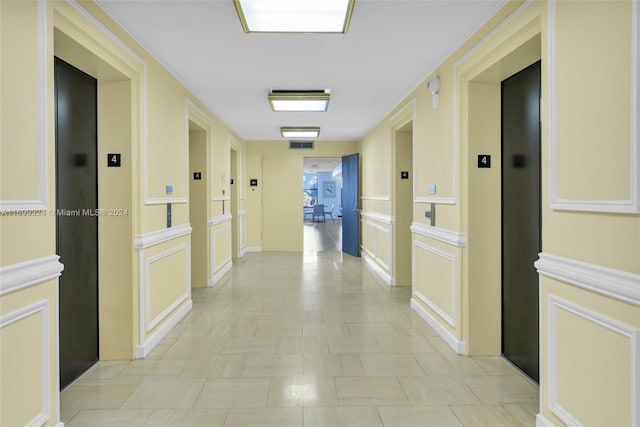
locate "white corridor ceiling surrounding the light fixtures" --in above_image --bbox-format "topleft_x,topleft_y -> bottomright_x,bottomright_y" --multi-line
98,0 -> 504,141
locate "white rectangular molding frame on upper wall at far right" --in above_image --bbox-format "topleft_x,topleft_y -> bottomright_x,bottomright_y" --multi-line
547,0 -> 640,213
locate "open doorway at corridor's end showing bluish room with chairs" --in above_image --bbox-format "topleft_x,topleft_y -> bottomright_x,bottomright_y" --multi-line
302,157 -> 342,252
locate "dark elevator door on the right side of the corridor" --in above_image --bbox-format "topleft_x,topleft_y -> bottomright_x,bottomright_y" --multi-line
502,62 -> 541,381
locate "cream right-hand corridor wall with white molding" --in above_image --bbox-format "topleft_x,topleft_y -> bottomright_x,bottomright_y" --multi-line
361,1 -> 640,425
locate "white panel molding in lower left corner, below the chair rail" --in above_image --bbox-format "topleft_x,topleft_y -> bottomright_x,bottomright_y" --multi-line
0,300 -> 50,426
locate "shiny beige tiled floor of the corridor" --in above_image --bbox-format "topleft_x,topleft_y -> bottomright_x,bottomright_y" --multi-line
61,251 -> 539,427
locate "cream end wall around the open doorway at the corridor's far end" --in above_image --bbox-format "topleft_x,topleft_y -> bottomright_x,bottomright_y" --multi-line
245,141 -> 358,251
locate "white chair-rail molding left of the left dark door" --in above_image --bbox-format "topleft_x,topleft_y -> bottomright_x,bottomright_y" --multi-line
0,255 -> 64,296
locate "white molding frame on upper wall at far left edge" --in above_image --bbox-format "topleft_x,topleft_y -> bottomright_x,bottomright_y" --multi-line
0,1 -> 49,211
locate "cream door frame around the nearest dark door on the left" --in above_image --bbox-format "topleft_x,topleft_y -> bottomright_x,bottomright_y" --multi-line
52,3 -> 146,360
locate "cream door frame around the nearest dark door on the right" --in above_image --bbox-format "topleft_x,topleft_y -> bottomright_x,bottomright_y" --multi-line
456,28 -> 546,355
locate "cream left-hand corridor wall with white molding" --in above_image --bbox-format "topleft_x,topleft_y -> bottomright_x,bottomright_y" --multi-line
0,1 -> 244,425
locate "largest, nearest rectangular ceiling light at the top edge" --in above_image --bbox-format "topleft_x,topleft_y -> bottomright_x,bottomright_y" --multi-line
233,0 -> 355,33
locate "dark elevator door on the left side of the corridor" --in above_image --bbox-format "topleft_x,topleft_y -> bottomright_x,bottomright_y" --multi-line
55,58 -> 98,389
